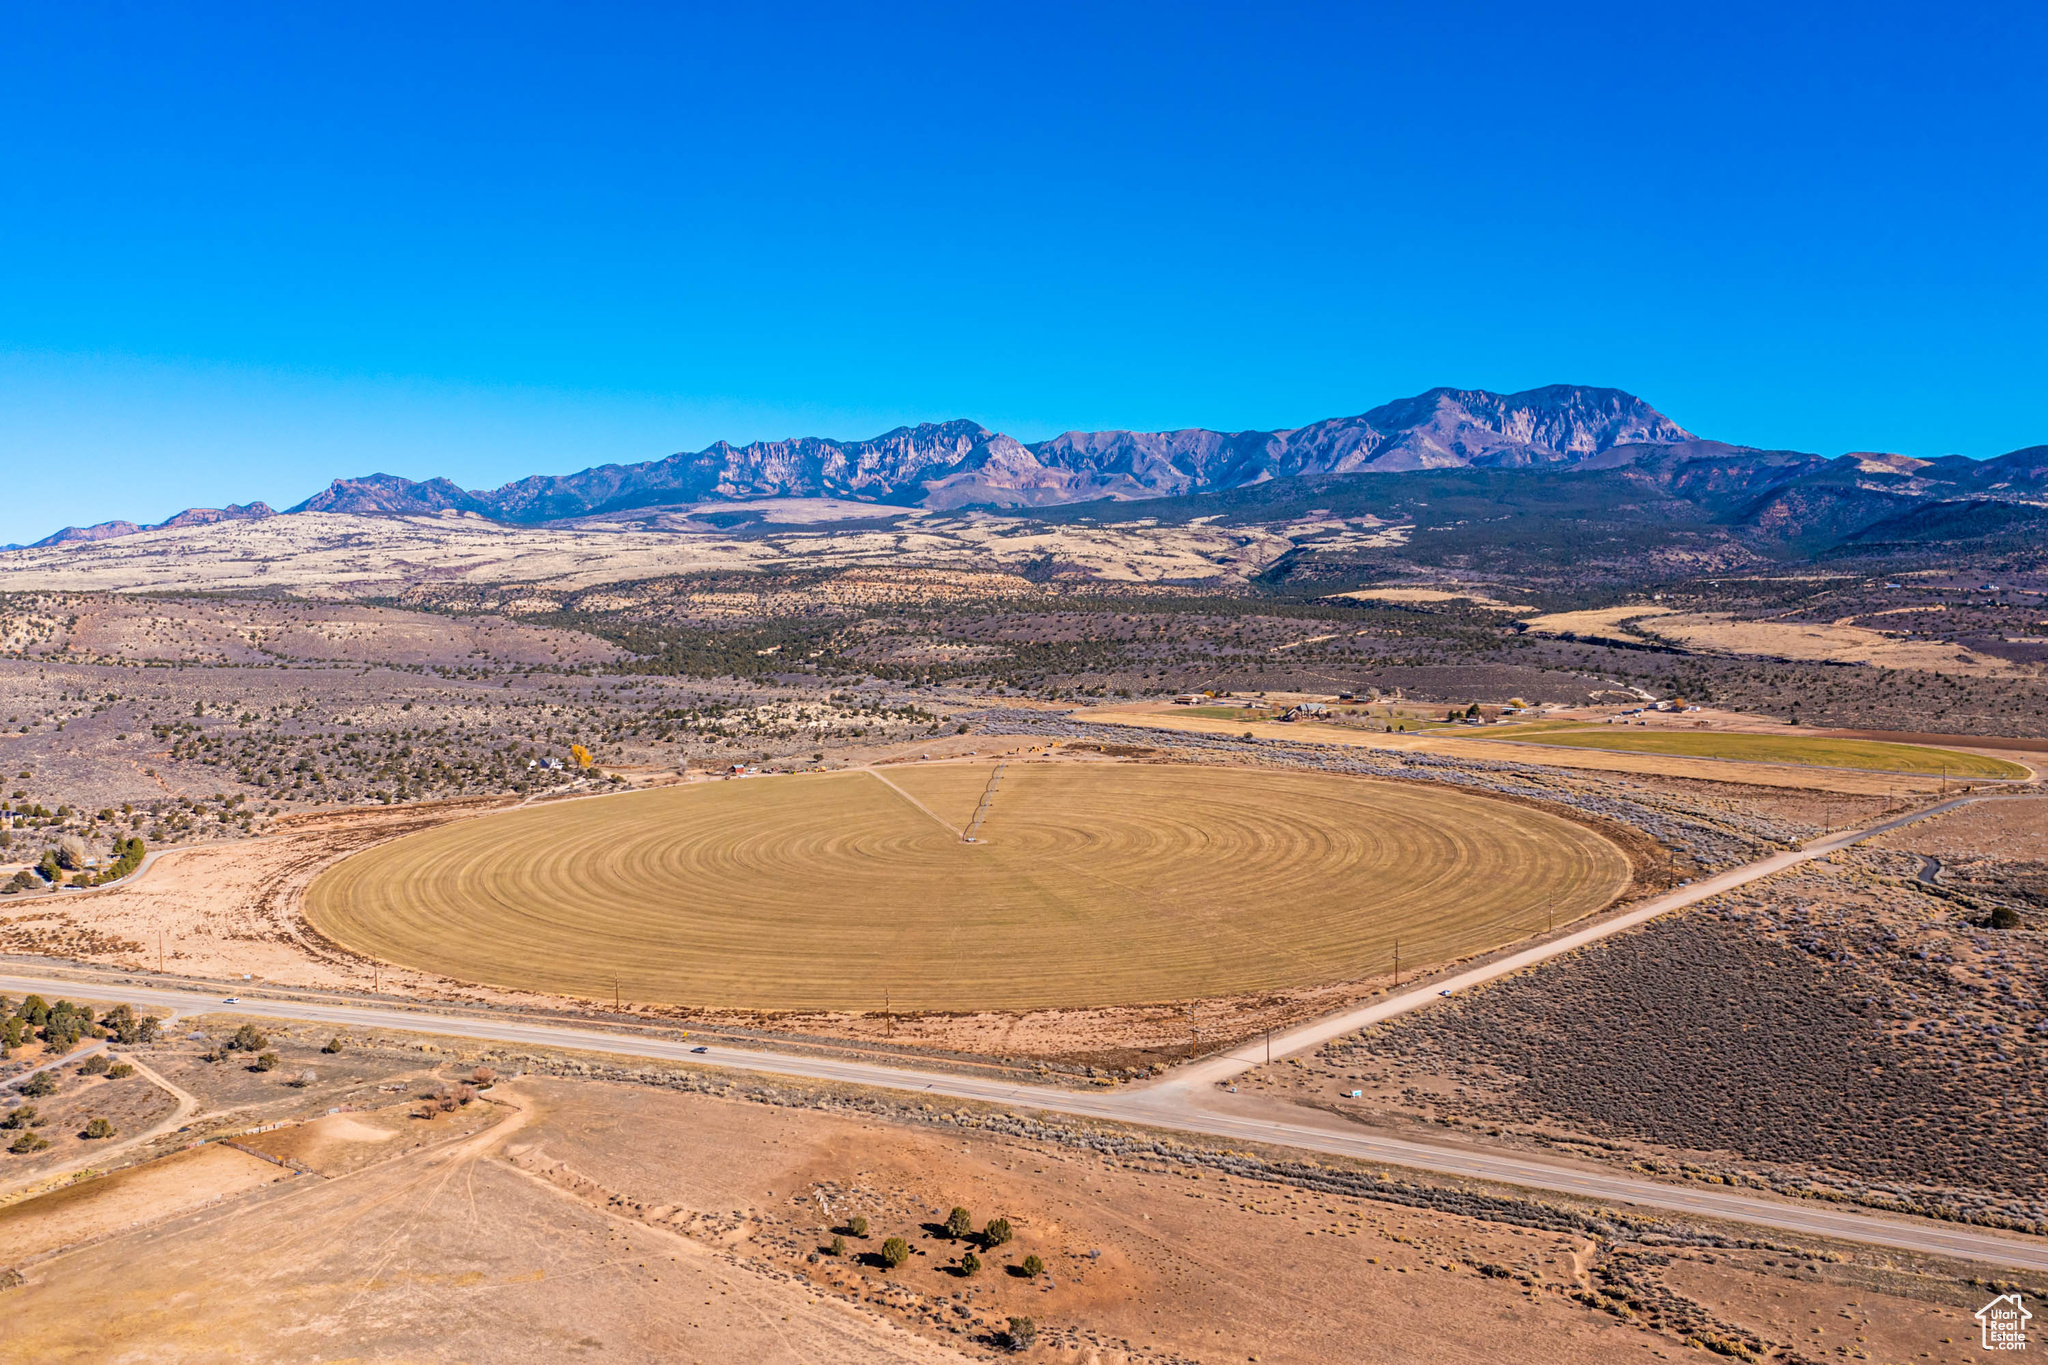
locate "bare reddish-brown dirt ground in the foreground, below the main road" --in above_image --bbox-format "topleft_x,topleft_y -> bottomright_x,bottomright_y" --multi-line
0,1017 -> 2015,1365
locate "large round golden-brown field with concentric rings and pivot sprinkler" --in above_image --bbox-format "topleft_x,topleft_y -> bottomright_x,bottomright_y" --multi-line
307,761 -> 1628,1011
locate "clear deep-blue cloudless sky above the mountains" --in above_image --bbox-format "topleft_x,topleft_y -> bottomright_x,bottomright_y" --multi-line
0,2 -> 2048,540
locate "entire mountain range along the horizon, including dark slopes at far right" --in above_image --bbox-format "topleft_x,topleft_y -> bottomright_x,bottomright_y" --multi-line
19,385 -> 2048,544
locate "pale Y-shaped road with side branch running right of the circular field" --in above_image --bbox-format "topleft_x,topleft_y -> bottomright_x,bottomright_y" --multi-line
0,796 -> 2048,1271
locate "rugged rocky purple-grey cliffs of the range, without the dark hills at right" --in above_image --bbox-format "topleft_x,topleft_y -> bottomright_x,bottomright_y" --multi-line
280,385 -> 1690,522
